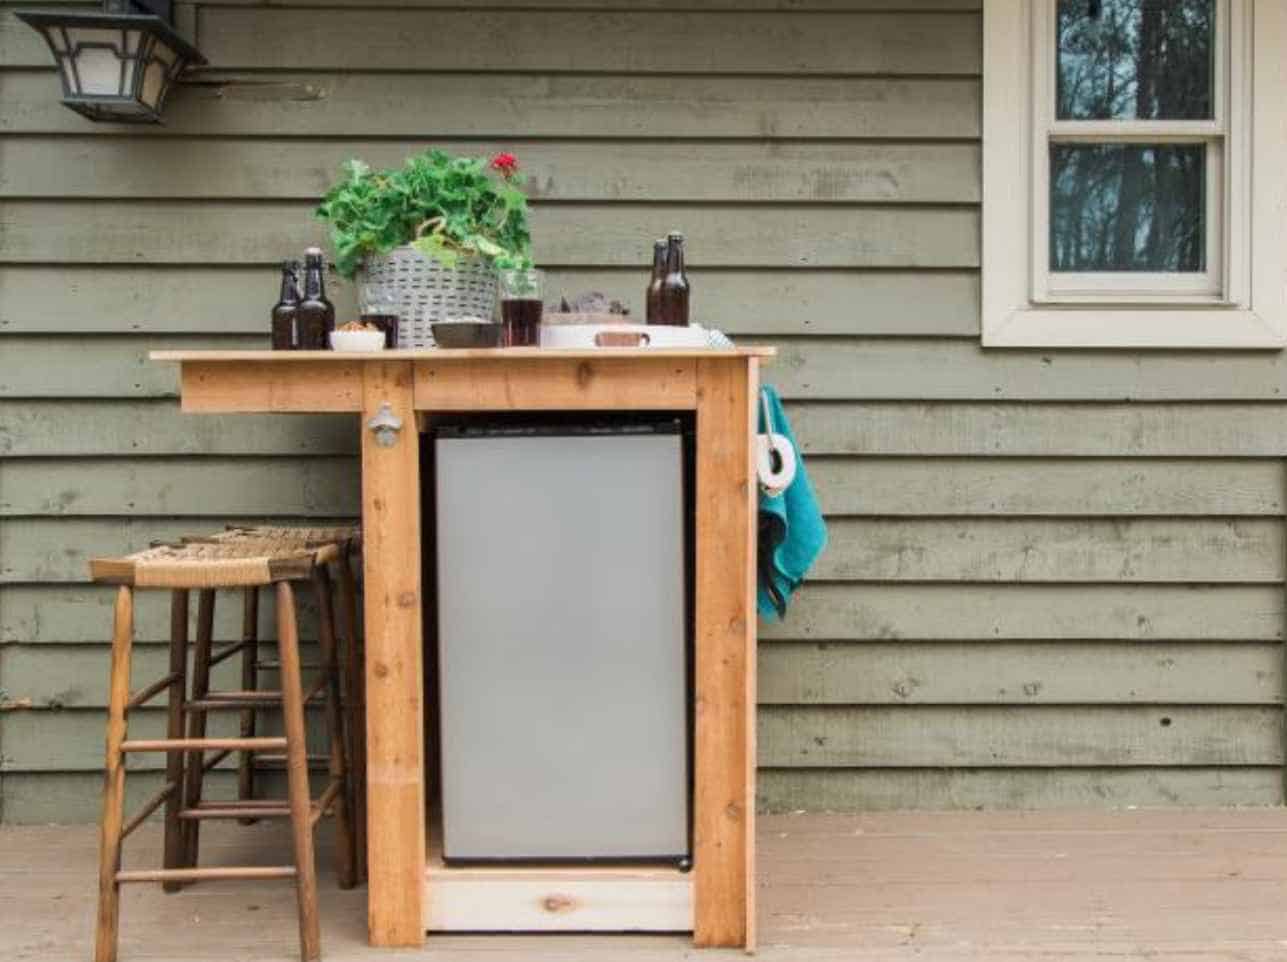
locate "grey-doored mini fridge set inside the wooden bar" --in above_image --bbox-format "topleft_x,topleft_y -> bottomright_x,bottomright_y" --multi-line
432,420 -> 691,864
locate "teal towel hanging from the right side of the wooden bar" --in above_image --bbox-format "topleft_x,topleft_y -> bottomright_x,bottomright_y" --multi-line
758,385 -> 826,619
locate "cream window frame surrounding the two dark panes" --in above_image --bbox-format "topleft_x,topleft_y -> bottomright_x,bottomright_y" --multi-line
982,0 -> 1287,349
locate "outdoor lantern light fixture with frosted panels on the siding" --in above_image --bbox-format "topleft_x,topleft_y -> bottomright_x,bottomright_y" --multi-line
14,0 -> 206,124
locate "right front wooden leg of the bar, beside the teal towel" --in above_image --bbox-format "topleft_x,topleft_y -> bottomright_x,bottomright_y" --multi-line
692,358 -> 758,950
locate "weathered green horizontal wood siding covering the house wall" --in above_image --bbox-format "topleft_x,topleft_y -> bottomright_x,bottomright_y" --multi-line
0,0 -> 1287,822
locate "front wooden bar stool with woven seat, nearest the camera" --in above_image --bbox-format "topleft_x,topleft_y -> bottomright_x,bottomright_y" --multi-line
90,542 -> 354,962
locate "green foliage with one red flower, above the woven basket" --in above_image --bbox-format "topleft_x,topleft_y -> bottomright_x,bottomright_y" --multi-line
317,151 -> 532,277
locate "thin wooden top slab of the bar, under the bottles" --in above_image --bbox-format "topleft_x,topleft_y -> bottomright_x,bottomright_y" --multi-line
148,346 -> 777,364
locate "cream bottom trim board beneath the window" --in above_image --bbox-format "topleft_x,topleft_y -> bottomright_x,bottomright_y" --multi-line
983,308 -> 1287,350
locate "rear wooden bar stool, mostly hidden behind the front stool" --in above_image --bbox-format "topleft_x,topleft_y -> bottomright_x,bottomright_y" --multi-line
184,522 -> 367,881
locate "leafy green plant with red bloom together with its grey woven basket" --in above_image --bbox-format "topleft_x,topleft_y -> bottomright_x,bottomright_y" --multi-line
317,149 -> 532,348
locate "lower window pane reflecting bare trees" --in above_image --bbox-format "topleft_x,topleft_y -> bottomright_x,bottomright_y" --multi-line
1050,143 -> 1207,272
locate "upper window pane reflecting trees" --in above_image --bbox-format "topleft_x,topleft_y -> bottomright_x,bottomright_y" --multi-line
1055,0 -> 1215,120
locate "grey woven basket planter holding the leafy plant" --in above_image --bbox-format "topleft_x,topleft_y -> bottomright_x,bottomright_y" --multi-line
366,246 -> 497,348
